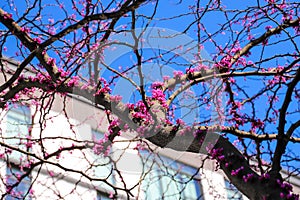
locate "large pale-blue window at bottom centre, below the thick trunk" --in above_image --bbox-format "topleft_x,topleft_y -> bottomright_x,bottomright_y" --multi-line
142,153 -> 203,200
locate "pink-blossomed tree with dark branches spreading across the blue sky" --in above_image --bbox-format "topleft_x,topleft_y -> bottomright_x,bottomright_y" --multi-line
0,0 -> 300,199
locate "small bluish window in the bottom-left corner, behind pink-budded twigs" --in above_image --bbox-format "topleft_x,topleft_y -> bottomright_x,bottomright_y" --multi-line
6,167 -> 31,200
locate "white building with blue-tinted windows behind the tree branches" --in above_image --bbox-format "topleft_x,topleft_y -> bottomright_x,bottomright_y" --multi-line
0,59 -> 300,200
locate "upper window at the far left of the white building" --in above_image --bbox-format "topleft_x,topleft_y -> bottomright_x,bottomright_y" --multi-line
4,105 -> 31,161
